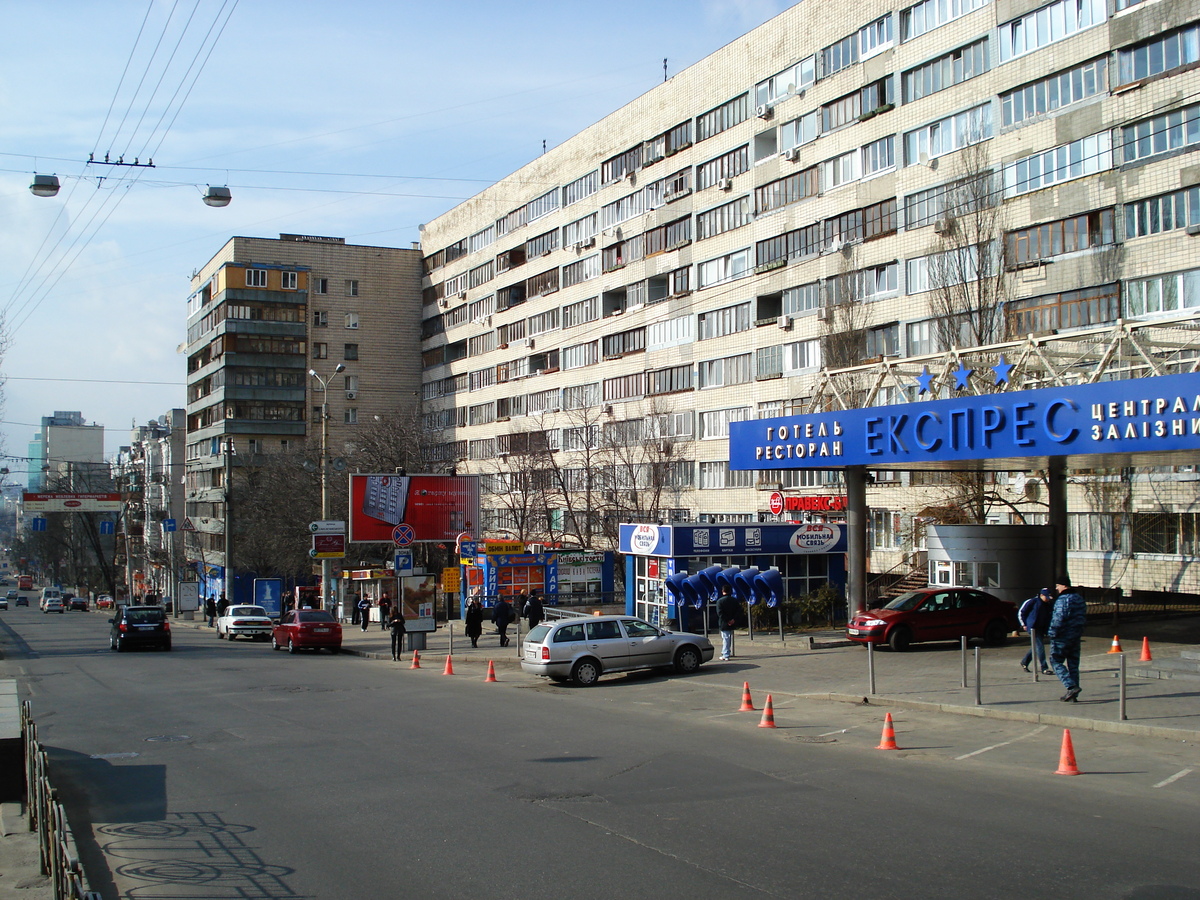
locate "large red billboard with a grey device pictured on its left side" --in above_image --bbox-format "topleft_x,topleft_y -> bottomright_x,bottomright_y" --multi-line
347,474 -> 479,544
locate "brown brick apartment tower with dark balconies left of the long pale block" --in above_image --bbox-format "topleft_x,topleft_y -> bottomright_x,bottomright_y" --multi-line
186,234 -> 421,598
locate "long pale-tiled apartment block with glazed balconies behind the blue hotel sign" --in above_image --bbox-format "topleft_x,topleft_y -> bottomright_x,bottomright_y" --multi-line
421,0 -> 1200,600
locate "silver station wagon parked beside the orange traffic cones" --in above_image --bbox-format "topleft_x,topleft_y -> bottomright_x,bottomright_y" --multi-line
521,616 -> 714,688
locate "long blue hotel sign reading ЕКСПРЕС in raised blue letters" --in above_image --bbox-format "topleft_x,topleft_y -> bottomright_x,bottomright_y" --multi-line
730,373 -> 1200,469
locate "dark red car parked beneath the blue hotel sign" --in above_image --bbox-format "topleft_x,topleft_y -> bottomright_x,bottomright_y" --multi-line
846,588 -> 1018,650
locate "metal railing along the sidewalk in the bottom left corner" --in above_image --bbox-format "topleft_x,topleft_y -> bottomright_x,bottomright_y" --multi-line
20,700 -> 101,900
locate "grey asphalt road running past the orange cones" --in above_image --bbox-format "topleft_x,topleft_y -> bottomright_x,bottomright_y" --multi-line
0,607 -> 1200,900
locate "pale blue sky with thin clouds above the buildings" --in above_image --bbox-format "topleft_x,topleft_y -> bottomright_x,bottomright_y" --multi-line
0,0 -> 791,472
